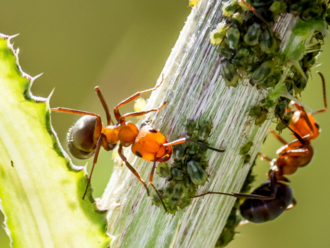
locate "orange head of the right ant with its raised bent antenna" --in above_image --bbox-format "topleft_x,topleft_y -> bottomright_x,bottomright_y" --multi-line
289,72 -> 328,140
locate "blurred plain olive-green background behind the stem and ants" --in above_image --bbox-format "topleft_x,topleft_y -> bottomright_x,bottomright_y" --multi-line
0,0 -> 330,248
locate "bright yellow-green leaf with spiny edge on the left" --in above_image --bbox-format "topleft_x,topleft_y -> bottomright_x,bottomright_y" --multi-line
0,35 -> 109,248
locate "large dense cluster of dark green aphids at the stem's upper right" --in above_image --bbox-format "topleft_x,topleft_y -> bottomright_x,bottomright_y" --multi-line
210,0 -> 330,134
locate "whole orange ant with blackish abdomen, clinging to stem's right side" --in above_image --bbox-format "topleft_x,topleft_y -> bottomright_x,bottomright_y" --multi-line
192,72 -> 327,223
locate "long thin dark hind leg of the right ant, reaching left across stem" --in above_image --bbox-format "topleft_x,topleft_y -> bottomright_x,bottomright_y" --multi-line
191,171 -> 277,200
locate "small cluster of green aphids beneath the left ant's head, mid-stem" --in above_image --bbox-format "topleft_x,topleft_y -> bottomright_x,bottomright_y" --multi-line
153,120 -> 212,213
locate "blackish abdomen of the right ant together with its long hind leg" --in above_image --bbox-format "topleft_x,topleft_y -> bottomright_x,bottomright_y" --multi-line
192,171 -> 297,223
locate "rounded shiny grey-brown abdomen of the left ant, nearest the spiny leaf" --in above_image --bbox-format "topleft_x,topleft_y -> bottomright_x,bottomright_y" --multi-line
67,115 -> 98,159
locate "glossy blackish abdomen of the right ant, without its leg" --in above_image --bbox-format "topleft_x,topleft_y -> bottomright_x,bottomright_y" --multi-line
240,181 -> 293,223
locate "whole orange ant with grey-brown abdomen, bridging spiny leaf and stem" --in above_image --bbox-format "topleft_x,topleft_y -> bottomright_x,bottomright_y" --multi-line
51,76 -> 224,212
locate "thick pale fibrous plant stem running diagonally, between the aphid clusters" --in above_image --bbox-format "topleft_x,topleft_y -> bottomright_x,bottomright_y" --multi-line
99,0 -> 310,248
